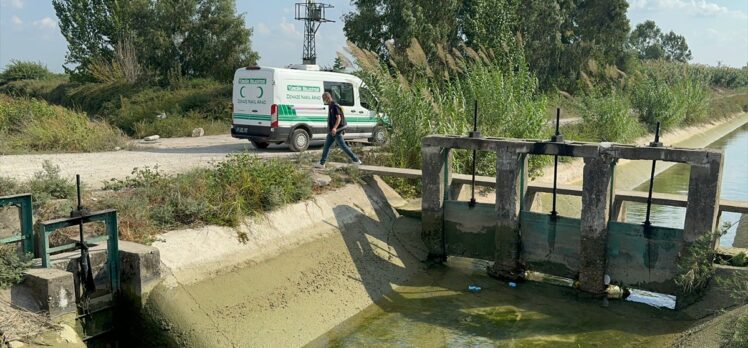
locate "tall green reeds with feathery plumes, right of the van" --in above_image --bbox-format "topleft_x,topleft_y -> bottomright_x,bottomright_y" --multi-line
351,42 -> 546,175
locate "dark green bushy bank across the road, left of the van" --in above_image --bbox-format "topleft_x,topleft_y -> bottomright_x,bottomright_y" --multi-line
0,78 -> 231,138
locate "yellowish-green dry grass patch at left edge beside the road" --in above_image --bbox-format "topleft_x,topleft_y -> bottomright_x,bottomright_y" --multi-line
0,95 -> 125,154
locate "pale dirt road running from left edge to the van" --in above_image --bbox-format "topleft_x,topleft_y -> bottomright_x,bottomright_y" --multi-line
0,135 -> 352,188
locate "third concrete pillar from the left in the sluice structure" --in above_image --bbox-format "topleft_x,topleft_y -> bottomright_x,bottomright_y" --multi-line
579,157 -> 613,294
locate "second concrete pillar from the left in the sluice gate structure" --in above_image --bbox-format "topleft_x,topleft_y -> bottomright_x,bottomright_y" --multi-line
489,149 -> 527,279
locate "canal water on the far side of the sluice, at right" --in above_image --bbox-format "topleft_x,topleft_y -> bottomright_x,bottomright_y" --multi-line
626,124 -> 748,246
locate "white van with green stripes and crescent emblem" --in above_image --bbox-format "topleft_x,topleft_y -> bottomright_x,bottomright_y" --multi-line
231,65 -> 385,151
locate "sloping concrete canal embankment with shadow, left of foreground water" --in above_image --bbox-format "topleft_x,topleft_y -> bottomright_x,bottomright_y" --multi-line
142,178 -> 426,347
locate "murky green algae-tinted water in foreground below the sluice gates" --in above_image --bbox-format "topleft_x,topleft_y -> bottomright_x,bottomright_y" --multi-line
309,258 -> 691,347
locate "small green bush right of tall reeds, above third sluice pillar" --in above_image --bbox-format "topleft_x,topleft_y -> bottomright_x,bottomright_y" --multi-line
582,94 -> 643,142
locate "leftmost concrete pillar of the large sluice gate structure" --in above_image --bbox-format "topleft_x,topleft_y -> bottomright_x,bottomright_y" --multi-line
421,146 -> 452,261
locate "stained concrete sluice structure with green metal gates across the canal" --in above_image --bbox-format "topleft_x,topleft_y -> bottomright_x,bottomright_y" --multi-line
421,136 -> 723,294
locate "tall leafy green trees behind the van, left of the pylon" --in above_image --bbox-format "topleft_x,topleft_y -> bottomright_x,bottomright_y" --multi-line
52,0 -> 258,80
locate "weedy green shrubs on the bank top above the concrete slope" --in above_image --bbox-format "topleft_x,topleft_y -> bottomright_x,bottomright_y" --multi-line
97,154 -> 312,241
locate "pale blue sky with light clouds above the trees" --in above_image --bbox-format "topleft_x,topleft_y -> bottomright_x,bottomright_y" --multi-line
0,0 -> 748,72
